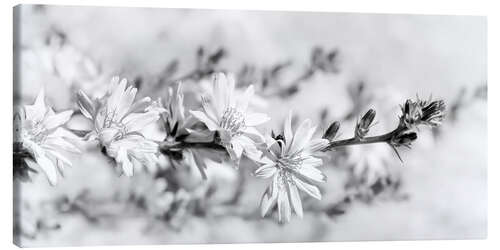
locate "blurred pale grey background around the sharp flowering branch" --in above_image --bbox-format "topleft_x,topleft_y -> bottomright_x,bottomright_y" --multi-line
14,5 -> 487,246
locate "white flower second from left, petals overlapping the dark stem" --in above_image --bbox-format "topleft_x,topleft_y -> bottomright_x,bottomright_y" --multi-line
78,77 -> 159,176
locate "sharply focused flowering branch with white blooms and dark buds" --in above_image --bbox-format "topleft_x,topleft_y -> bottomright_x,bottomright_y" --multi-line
14,71 -> 445,225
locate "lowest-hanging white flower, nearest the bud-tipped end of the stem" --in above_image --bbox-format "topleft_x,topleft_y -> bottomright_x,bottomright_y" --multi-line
255,113 -> 328,222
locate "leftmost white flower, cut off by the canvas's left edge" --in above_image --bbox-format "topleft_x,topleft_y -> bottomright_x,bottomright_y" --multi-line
14,90 -> 80,185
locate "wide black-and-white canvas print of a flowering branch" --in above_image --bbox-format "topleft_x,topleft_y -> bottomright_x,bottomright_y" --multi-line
13,5 -> 488,247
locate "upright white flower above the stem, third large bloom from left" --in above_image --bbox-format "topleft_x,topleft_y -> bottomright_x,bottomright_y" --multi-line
190,73 -> 270,162
